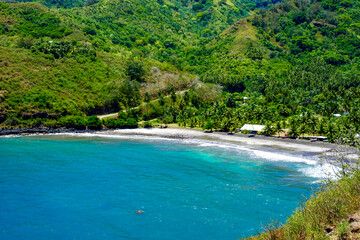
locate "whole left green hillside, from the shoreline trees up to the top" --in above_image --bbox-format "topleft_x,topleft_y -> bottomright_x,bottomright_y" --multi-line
0,0 -> 253,122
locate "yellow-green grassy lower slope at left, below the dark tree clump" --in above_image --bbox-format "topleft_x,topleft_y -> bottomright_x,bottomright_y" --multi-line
0,43 -> 190,115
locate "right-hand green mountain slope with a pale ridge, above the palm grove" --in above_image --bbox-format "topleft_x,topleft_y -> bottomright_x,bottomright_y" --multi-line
195,1 -> 360,124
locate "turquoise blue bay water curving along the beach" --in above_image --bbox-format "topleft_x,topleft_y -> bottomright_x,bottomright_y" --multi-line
0,135 -> 318,240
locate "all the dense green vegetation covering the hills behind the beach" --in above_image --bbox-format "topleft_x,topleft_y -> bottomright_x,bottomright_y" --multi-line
0,0 -> 360,142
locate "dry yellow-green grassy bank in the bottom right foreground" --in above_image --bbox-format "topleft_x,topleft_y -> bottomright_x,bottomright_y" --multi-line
249,171 -> 360,240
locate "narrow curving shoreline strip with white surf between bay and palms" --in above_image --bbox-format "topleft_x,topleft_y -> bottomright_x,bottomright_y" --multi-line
0,127 -> 357,159
